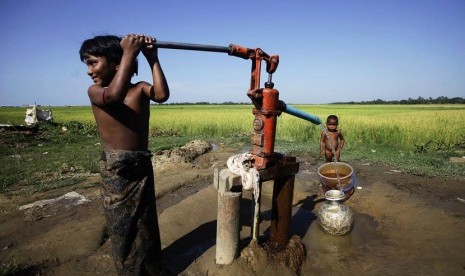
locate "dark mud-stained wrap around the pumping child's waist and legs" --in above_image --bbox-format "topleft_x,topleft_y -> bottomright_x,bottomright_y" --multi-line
100,150 -> 161,275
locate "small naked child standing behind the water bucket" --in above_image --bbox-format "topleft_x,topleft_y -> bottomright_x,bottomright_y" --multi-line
320,115 -> 345,162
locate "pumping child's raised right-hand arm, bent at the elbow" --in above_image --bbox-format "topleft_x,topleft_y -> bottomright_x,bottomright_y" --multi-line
142,36 -> 170,103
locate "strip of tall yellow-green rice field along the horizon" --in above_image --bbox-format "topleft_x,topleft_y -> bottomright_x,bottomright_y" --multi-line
0,105 -> 465,149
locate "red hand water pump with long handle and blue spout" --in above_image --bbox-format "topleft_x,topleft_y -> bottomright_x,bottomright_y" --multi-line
154,41 -> 321,250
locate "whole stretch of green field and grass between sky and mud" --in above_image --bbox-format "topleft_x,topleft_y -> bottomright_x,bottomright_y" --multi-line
0,105 -> 465,194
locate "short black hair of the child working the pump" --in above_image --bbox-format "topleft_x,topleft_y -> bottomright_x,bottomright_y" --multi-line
79,35 -> 138,75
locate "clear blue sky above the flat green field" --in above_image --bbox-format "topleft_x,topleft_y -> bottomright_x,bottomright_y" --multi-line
0,0 -> 465,106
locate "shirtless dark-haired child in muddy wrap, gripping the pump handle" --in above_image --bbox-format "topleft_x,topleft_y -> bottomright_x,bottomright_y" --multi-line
79,34 -> 170,275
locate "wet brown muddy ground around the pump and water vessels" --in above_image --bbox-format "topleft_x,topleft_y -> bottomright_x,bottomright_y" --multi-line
0,141 -> 465,275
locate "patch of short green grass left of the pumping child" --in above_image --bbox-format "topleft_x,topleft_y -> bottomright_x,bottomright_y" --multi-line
0,122 -> 102,194
